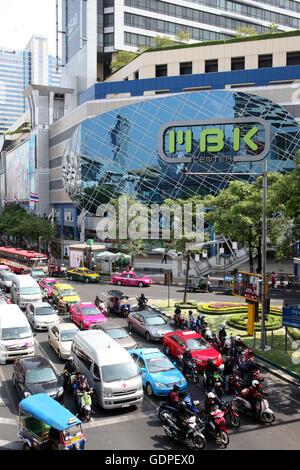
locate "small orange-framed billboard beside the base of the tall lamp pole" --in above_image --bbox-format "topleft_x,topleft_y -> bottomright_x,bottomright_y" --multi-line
232,271 -> 262,302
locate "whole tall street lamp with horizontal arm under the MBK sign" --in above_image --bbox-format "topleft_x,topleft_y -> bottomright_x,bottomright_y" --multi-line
180,158 -> 268,351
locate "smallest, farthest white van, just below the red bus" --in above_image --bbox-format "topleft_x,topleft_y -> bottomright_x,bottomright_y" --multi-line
10,274 -> 43,308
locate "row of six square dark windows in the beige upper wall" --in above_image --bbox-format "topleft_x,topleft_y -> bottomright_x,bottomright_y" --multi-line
155,51 -> 300,77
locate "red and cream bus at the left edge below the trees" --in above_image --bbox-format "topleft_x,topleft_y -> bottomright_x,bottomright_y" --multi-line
0,246 -> 48,274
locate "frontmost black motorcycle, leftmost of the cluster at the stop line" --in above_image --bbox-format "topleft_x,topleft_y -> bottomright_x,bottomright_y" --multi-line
163,413 -> 206,449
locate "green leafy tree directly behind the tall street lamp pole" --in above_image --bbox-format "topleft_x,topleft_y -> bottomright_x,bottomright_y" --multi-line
204,172 -> 288,273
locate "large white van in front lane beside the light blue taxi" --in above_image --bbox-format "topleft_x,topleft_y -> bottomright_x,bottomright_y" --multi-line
71,330 -> 144,409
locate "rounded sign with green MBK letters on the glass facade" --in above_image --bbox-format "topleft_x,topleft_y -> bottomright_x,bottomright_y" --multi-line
159,118 -> 270,163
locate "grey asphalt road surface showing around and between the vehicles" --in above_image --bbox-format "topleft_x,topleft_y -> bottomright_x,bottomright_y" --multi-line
0,282 -> 300,451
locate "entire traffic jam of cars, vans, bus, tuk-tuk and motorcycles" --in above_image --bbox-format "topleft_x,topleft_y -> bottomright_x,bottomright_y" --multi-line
0,247 -> 275,450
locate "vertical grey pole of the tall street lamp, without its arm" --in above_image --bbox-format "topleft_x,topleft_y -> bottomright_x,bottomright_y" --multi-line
260,159 -> 267,351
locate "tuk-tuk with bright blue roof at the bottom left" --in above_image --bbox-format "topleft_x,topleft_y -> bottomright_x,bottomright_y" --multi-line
18,393 -> 86,450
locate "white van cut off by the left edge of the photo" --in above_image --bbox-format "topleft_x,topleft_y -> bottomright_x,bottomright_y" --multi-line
0,304 -> 34,364
